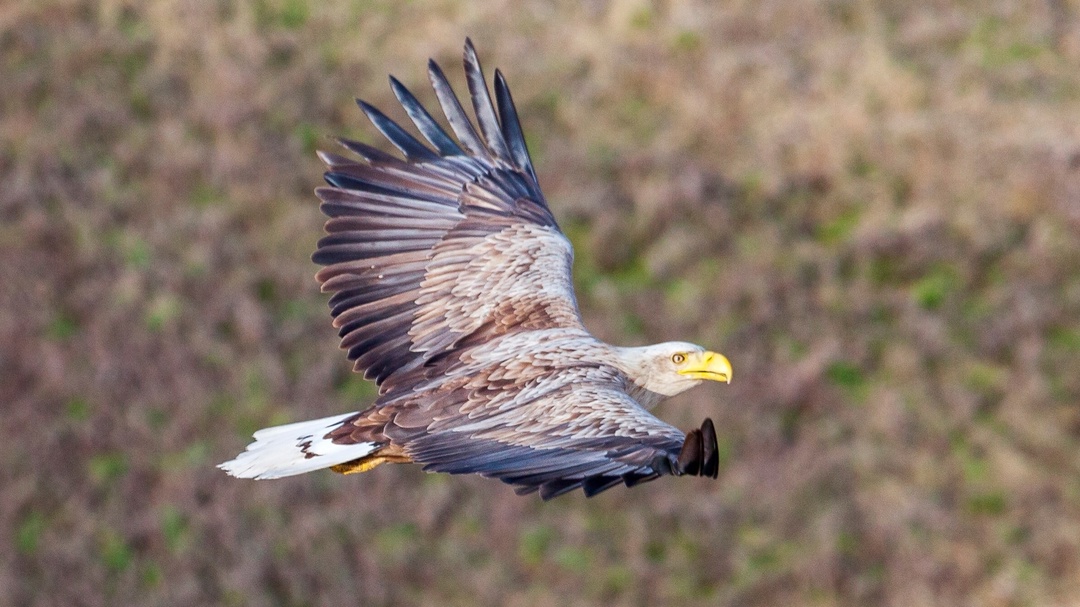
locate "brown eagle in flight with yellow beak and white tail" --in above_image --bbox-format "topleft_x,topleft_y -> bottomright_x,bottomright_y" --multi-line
219,40 -> 731,500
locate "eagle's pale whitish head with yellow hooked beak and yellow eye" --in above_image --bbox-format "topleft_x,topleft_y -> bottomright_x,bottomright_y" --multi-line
616,341 -> 731,396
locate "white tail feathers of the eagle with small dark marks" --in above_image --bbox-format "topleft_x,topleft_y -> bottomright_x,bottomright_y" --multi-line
217,413 -> 381,478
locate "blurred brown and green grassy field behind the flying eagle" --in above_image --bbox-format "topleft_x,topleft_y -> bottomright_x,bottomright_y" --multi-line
0,0 -> 1080,607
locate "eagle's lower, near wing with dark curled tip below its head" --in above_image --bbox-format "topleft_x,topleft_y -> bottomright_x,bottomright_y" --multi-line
406,387 -> 719,500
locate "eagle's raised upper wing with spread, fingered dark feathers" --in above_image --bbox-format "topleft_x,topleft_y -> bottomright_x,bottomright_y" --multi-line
312,41 -> 583,393
